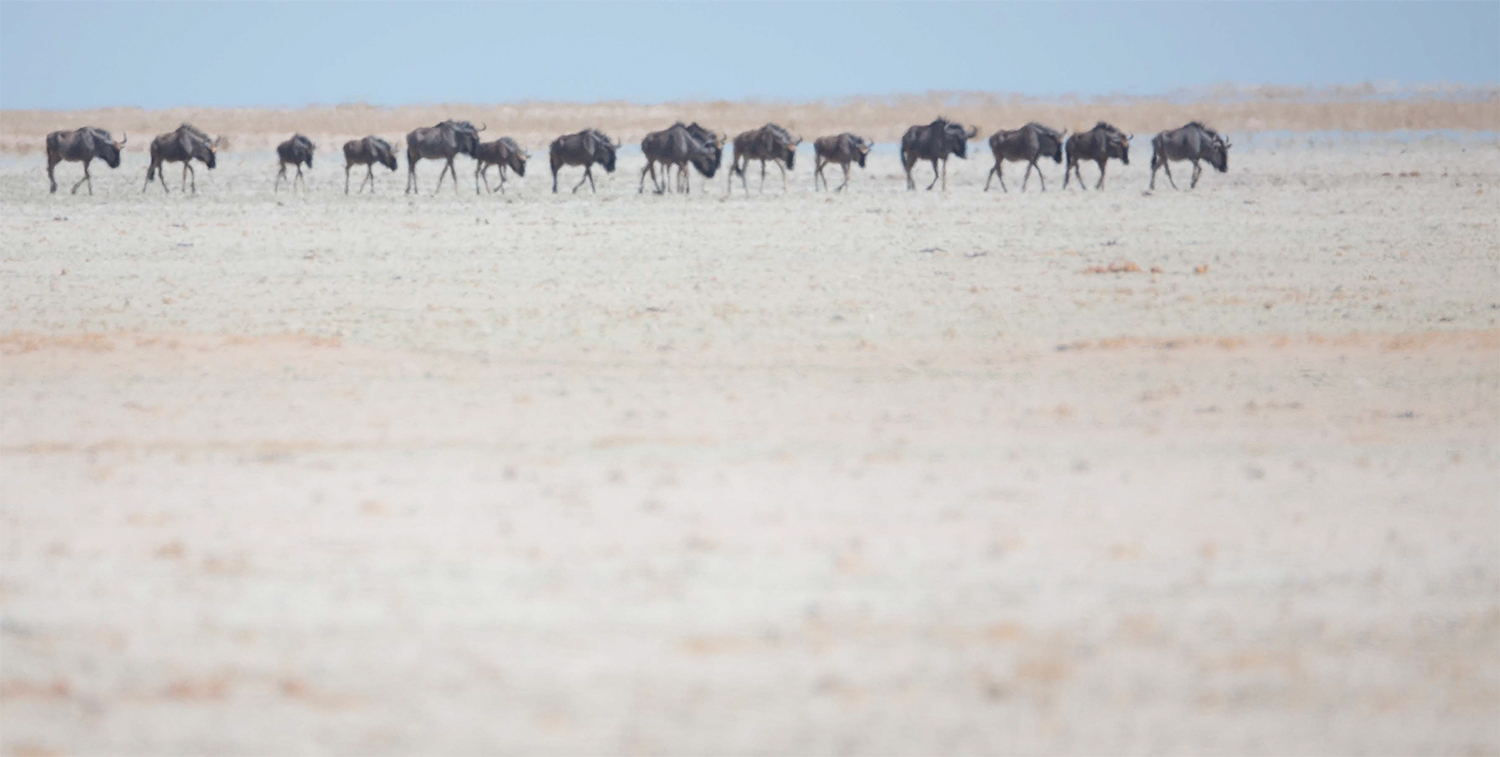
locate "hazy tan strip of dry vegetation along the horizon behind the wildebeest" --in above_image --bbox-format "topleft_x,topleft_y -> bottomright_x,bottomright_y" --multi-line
0,85 -> 1500,153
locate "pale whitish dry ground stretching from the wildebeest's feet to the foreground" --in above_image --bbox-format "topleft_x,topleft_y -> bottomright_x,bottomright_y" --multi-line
0,141 -> 1500,754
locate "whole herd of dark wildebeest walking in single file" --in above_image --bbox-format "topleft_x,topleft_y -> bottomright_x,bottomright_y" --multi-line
47,118 -> 1230,195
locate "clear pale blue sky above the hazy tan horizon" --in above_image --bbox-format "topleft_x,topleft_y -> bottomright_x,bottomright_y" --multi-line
0,0 -> 1500,108
